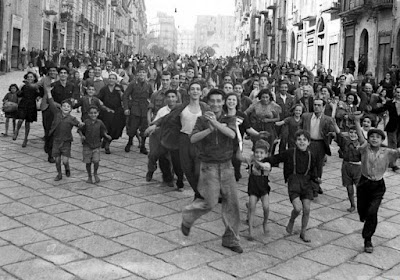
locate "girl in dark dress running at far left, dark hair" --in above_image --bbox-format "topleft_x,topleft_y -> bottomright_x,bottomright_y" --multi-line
13,72 -> 43,148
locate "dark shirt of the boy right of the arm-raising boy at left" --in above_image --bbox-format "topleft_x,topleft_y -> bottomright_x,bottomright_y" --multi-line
79,119 -> 107,149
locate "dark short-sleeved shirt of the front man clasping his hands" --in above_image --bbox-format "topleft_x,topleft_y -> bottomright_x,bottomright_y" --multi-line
192,112 -> 236,163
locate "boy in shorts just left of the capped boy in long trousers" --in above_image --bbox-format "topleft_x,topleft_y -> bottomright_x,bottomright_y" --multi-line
335,123 -> 361,213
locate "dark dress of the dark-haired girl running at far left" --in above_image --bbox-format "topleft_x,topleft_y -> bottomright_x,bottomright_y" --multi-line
17,85 -> 42,122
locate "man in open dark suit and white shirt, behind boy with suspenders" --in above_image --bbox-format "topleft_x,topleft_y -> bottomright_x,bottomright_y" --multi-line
301,99 -> 335,197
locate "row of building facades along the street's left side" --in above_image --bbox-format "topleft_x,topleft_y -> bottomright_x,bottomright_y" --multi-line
0,0 -> 147,71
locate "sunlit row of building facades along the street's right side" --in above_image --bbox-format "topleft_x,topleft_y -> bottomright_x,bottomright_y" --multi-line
235,0 -> 400,79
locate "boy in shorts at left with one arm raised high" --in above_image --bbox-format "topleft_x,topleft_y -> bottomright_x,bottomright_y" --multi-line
47,88 -> 83,181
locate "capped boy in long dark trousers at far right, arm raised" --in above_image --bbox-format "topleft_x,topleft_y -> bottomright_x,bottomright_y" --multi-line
355,114 -> 400,253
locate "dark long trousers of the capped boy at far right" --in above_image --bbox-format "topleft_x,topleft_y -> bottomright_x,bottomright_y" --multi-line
357,176 -> 386,241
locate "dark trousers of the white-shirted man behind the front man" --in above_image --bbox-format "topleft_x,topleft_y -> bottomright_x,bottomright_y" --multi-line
179,133 -> 202,198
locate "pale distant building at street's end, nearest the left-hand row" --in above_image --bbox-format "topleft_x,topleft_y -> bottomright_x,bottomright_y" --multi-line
147,12 -> 178,53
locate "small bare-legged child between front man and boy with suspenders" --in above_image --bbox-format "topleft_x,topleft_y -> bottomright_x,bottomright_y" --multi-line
241,140 -> 271,241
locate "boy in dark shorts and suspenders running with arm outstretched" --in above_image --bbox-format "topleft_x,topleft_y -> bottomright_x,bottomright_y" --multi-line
266,129 -> 319,242
